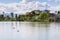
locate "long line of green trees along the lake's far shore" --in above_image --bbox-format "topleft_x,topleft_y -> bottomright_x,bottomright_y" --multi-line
0,10 -> 60,22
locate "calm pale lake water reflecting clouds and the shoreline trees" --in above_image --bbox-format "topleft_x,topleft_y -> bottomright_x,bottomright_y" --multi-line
0,22 -> 60,40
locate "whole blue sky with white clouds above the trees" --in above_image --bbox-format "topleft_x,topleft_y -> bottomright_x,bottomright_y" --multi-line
0,0 -> 60,13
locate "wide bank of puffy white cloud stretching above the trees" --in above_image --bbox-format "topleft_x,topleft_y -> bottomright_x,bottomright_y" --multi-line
0,0 -> 60,13
